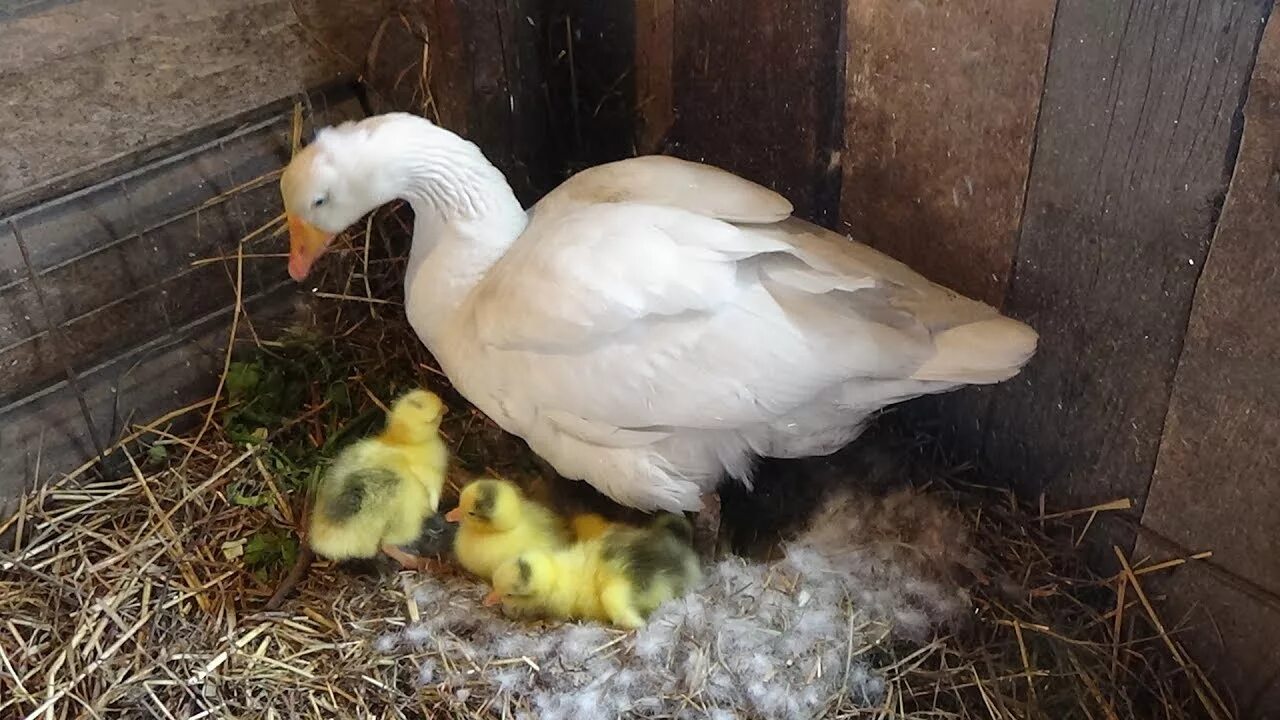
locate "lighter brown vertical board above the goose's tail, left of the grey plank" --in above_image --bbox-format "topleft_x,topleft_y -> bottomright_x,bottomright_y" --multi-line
841,0 -> 1056,306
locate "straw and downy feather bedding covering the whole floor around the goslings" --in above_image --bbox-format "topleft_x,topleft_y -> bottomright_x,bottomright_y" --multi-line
0,165 -> 1231,719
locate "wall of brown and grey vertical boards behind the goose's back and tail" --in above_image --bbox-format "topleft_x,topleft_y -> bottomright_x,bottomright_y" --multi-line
636,0 -> 1280,716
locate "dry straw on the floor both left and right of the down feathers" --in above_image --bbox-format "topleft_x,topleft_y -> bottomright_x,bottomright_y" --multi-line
0,114 -> 1231,719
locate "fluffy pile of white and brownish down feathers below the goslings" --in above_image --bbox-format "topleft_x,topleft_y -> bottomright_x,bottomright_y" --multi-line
378,491 -> 973,720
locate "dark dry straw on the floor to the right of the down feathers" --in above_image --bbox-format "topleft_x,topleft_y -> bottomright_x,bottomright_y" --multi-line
881,478 -> 1234,720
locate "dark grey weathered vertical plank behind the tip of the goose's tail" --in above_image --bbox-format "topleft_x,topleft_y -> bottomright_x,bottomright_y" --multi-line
984,0 -> 1271,515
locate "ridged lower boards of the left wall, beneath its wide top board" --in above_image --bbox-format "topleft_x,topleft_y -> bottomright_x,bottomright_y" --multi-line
0,88 -> 364,497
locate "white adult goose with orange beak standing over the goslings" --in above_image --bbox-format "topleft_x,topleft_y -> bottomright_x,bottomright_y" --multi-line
280,113 -> 1037,520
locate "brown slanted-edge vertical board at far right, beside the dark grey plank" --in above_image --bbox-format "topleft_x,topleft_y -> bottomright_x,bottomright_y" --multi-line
1143,7 -> 1280,592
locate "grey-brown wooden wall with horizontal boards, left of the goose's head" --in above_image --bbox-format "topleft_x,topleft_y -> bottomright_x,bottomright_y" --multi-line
0,0 -> 389,505
